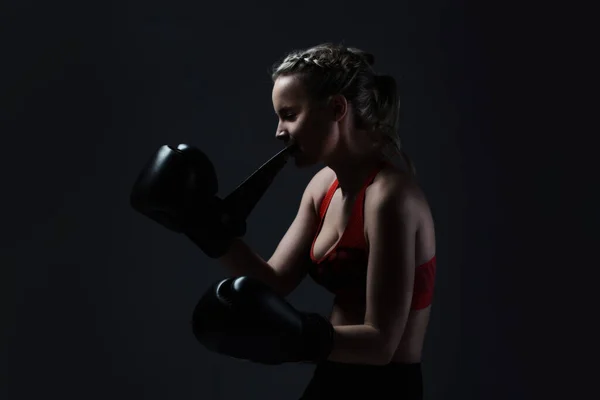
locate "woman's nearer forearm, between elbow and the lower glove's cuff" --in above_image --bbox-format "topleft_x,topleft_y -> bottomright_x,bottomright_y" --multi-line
328,325 -> 390,365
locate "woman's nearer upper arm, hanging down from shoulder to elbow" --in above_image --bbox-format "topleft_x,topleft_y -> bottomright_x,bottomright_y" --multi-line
365,184 -> 419,355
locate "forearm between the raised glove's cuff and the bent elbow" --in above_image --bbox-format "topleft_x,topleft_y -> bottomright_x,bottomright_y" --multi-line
218,238 -> 282,294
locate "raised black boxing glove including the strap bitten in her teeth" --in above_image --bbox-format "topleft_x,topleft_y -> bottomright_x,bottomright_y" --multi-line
130,144 -> 296,258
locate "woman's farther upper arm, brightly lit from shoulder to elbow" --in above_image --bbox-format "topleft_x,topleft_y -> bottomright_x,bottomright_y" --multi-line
268,169 -> 327,293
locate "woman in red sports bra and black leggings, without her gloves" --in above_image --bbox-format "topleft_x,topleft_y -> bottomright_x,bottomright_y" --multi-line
220,44 -> 436,399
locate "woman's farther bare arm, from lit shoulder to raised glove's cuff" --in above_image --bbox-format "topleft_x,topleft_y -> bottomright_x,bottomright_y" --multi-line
219,169 -> 327,297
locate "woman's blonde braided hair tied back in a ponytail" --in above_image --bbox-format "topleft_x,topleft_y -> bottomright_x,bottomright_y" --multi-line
270,43 -> 416,176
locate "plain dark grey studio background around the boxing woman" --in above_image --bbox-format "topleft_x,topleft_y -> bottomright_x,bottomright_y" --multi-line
0,0 -> 598,400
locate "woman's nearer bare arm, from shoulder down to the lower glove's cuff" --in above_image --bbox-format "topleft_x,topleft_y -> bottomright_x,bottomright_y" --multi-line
329,185 -> 419,365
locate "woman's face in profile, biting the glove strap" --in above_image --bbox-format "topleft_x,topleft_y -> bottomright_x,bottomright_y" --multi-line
272,76 -> 336,166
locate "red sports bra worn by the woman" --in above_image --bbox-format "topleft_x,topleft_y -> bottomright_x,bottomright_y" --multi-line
309,167 -> 436,310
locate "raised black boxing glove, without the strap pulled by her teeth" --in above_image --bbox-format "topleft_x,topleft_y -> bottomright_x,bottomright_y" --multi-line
130,144 -> 246,258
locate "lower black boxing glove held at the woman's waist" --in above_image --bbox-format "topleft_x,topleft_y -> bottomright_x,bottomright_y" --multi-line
192,277 -> 333,365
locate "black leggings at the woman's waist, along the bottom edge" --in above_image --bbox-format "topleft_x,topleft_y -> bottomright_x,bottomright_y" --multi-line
301,361 -> 423,400
